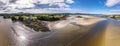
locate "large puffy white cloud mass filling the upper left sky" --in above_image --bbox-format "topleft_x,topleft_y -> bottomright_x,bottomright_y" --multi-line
0,0 -> 74,12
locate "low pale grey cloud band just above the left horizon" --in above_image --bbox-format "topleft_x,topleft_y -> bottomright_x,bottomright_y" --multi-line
0,8 -> 72,13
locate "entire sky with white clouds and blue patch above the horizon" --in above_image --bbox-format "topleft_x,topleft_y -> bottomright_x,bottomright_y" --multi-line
0,0 -> 120,14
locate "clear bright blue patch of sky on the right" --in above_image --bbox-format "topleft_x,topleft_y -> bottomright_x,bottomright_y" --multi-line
71,0 -> 120,14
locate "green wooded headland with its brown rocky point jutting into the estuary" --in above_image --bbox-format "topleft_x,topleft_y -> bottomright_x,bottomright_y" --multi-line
3,14 -> 68,32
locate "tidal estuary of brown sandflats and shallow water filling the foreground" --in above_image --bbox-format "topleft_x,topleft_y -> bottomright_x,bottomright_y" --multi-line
0,16 -> 120,46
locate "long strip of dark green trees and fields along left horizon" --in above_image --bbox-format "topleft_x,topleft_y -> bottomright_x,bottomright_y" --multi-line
4,14 -> 66,21
